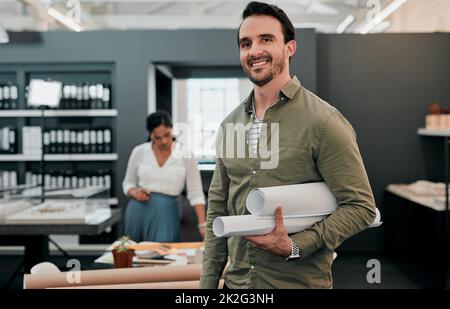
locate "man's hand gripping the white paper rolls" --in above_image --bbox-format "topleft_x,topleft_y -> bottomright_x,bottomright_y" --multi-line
243,206 -> 292,257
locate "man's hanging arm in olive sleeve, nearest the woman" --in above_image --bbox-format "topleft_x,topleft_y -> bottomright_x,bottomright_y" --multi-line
200,158 -> 230,289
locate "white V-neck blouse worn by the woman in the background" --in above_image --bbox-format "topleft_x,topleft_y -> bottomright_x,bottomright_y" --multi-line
122,142 -> 205,206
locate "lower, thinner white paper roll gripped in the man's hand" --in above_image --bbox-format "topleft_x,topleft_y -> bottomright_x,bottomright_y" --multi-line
213,214 -> 327,237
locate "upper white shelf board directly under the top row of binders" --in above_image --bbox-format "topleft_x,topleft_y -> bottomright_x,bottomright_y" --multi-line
0,109 -> 117,117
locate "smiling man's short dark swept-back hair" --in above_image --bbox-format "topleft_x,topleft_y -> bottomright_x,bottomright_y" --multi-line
237,1 -> 295,45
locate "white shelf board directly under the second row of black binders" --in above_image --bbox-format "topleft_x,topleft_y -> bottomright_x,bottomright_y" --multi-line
0,153 -> 118,162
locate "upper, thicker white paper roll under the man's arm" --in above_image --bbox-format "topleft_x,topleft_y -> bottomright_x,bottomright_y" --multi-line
246,182 -> 338,216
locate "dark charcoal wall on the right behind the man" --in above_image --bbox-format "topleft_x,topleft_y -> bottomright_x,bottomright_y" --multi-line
317,33 -> 450,250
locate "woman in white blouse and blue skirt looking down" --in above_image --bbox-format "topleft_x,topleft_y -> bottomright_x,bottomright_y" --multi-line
123,111 -> 205,242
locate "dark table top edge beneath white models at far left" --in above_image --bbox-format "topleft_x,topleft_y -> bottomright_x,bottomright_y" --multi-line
0,209 -> 121,235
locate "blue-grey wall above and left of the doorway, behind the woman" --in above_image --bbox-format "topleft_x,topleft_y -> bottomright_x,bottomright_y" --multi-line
0,29 -> 317,221
